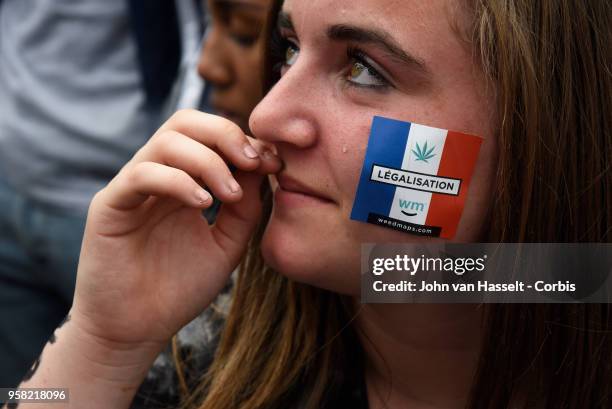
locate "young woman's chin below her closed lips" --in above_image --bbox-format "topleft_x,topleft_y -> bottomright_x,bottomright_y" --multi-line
261,220 -> 360,295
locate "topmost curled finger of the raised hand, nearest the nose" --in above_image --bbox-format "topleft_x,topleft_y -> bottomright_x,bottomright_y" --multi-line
158,110 -> 282,170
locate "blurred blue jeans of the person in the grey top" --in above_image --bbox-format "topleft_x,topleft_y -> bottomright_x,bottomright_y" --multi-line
0,177 -> 86,388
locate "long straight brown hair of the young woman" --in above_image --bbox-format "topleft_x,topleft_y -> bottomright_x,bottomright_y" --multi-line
180,0 -> 612,409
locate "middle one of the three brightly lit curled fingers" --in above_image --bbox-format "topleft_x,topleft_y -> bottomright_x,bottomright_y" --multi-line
137,131 -> 245,202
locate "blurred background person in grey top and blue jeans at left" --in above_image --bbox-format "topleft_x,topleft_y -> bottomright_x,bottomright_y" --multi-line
0,0 -> 202,387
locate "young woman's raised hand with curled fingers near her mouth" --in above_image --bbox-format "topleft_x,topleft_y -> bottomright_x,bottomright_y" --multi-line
72,111 -> 281,349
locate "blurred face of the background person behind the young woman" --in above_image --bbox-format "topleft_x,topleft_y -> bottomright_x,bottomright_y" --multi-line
198,0 -> 271,132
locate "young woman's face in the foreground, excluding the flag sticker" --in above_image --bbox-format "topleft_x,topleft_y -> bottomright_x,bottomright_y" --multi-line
250,0 -> 496,294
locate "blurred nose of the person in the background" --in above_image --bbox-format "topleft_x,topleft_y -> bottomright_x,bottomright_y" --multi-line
198,26 -> 233,88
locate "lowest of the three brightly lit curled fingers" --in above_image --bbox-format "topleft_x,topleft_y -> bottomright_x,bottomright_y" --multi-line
100,162 -> 213,210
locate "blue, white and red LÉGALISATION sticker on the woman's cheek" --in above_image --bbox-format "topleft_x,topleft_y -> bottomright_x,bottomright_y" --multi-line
351,116 -> 482,239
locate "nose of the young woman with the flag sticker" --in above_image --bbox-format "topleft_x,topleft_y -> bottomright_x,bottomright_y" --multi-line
249,62 -> 318,148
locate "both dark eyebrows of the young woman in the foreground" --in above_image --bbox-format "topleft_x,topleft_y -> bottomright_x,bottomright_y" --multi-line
278,11 -> 431,75
